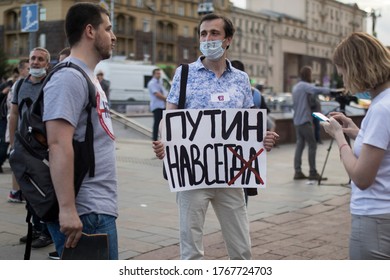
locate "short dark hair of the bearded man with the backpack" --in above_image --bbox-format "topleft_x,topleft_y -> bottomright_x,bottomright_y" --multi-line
65,2 -> 110,47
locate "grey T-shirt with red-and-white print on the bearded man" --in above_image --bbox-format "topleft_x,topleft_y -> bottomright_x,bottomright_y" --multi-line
43,58 -> 118,217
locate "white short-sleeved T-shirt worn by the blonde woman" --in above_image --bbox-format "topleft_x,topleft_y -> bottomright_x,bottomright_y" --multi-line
351,89 -> 390,215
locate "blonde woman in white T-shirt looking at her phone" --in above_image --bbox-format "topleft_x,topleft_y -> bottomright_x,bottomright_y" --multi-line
322,32 -> 390,260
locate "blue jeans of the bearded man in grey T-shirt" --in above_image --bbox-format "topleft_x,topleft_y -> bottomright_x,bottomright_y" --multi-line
47,213 -> 118,260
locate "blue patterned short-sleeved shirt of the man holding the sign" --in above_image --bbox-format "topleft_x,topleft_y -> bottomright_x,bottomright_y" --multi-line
167,57 -> 253,109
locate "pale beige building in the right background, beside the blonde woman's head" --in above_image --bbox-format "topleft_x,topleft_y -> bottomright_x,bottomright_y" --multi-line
247,0 -> 367,92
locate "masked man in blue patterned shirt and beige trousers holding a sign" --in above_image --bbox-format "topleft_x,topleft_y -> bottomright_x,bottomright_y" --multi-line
153,14 -> 279,259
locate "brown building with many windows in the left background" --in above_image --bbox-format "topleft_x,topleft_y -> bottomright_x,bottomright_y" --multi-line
0,0 -> 213,74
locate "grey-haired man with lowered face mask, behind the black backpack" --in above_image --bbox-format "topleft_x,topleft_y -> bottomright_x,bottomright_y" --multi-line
9,47 -> 53,248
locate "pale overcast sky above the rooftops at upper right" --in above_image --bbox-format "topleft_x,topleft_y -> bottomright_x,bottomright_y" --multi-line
230,0 -> 390,46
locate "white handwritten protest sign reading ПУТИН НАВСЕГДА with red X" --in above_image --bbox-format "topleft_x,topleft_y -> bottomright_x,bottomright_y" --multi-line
162,109 -> 267,192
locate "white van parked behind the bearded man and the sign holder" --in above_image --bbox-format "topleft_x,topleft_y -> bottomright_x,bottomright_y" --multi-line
95,60 -> 171,102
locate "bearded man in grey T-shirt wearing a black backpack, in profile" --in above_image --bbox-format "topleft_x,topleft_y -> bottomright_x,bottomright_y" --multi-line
43,2 -> 118,259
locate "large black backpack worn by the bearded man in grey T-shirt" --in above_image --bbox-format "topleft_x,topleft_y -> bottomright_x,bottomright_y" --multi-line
9,62 -> 96,222
